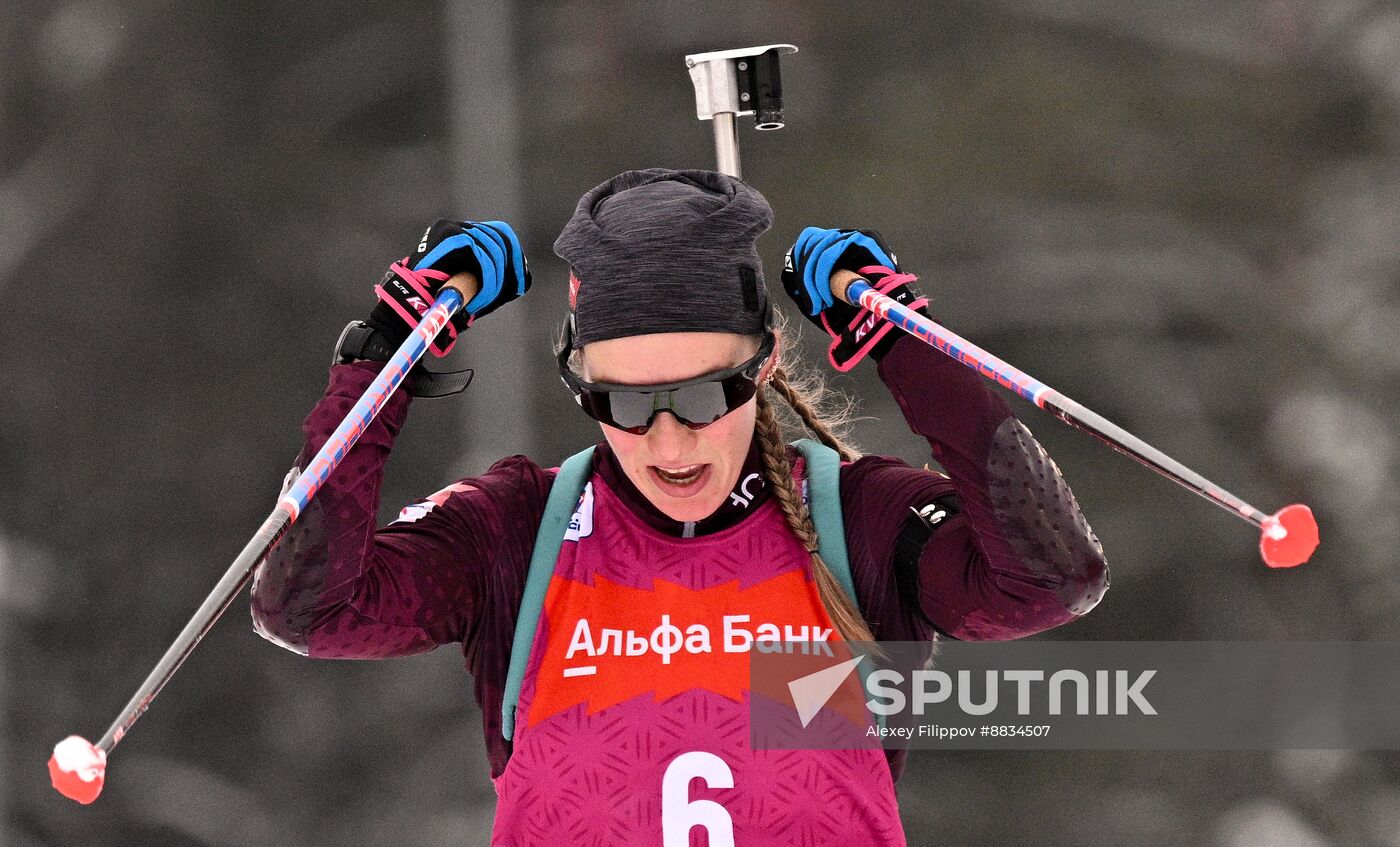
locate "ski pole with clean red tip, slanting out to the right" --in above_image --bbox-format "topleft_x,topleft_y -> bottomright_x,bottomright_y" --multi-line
832,270 -> 1317,567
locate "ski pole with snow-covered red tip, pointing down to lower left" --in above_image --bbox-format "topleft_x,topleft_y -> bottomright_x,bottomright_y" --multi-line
49,273 -> 480,805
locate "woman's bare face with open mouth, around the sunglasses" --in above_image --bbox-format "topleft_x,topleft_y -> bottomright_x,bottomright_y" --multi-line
582,332 -> 777,521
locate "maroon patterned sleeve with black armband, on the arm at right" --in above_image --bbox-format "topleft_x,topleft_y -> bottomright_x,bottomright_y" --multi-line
841,333 -> 1109,640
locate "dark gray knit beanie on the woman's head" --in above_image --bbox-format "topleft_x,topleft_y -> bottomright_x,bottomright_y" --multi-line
554,168 -> 773,349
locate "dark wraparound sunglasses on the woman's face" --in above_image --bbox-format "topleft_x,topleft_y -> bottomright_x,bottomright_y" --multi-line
559,322 -> 774,435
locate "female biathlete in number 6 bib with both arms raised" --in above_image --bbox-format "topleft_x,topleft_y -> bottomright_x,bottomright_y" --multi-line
252,169 -> 1107,847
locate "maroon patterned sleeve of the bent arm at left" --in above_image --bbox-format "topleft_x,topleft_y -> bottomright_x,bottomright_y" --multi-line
252,363 -> 549,658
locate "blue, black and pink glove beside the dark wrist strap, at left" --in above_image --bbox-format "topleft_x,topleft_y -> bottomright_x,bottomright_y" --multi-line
368,220 -> 531,356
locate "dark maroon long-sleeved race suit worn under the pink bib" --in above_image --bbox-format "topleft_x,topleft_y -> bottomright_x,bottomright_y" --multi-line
252,329 -> 1109,834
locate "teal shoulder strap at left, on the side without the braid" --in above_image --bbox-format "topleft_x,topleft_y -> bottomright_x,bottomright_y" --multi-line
501,447 -> 594,741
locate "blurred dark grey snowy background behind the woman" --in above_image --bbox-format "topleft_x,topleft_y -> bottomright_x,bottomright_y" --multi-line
0,0 -> 1400,847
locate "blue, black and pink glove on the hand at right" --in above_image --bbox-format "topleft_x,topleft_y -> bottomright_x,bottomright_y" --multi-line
783,227 -> 928,371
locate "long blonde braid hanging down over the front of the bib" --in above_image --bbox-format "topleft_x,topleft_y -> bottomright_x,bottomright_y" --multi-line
755,389 -> 875,641
